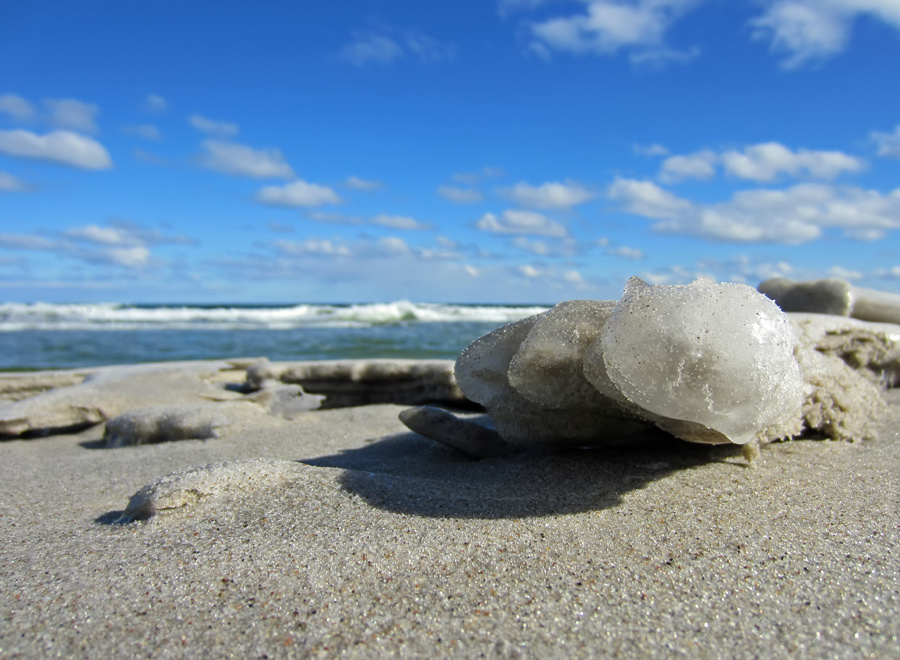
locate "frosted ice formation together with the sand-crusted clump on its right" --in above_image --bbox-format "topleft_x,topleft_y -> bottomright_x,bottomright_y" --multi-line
401,278 -> 900,457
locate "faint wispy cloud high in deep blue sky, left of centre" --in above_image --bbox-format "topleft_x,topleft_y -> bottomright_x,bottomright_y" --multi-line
338,30 -> 456,66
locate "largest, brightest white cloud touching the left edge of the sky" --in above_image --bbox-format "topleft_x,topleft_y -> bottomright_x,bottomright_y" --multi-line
0,130 -> 113,170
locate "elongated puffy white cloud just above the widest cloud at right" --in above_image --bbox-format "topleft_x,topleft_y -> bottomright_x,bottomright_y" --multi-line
721,142 -> 865,182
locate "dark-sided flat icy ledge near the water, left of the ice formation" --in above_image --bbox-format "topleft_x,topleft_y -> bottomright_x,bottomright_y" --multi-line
245,359 -> 466,408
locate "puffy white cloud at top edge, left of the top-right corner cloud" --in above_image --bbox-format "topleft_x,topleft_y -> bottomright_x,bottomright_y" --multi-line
531,0 -> 702,63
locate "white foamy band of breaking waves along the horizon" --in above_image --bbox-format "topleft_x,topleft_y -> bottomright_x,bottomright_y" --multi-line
0,300 -> 547,332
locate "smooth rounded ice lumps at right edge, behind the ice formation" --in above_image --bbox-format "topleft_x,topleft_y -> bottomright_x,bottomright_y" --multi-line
758,277 -> 900,323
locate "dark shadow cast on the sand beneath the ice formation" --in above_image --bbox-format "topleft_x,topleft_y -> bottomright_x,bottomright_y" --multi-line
302,431 -> 743,519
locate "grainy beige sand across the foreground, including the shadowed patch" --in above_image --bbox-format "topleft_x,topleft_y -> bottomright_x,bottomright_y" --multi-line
0,364 -> 900,658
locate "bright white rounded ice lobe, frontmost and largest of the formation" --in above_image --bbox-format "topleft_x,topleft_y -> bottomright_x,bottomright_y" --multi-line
586,278 -> 803,444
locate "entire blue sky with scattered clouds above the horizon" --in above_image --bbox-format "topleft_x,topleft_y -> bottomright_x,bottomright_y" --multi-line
0,0 -> 900,303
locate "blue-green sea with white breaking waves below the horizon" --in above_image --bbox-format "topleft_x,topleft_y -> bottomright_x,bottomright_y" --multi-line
0,301 -> 549,371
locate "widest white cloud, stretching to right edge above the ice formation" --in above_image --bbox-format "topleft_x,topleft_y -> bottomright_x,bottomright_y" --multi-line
608,179 -> 900,244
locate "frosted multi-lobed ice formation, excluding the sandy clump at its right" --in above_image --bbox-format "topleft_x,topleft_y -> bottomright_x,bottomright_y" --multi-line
456,278 -> 852,448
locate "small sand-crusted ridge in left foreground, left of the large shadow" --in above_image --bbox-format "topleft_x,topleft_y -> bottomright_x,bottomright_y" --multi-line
116,458 -> 306,523
